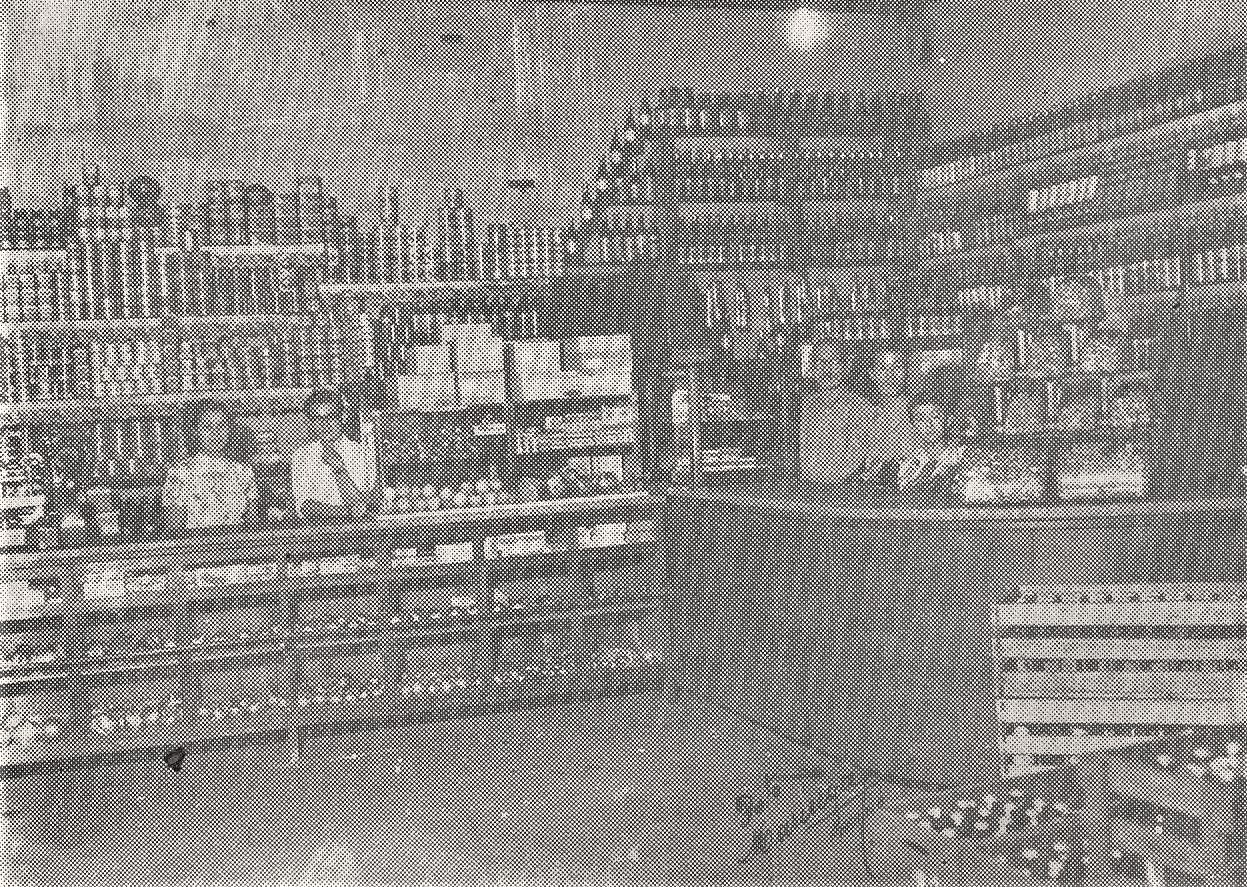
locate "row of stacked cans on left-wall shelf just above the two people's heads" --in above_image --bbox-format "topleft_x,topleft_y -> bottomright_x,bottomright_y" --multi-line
0,327 -> 344,404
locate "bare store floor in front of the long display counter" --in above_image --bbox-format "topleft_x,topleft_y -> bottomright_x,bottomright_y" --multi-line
0,700 -> 863,887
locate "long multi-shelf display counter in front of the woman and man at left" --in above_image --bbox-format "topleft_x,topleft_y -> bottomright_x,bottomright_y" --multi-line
0,493 -> 667,771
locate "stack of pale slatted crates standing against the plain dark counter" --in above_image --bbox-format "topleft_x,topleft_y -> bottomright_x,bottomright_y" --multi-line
993,583 -> 1247,775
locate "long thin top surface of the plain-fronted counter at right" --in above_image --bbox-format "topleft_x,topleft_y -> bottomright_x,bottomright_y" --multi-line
667,484 -> 1247,523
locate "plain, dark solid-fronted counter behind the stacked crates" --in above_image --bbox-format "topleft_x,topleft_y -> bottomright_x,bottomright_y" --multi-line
668,485 -> 1245,798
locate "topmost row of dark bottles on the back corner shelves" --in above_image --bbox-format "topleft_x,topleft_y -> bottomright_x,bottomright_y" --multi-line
638,89 -> 927,137
